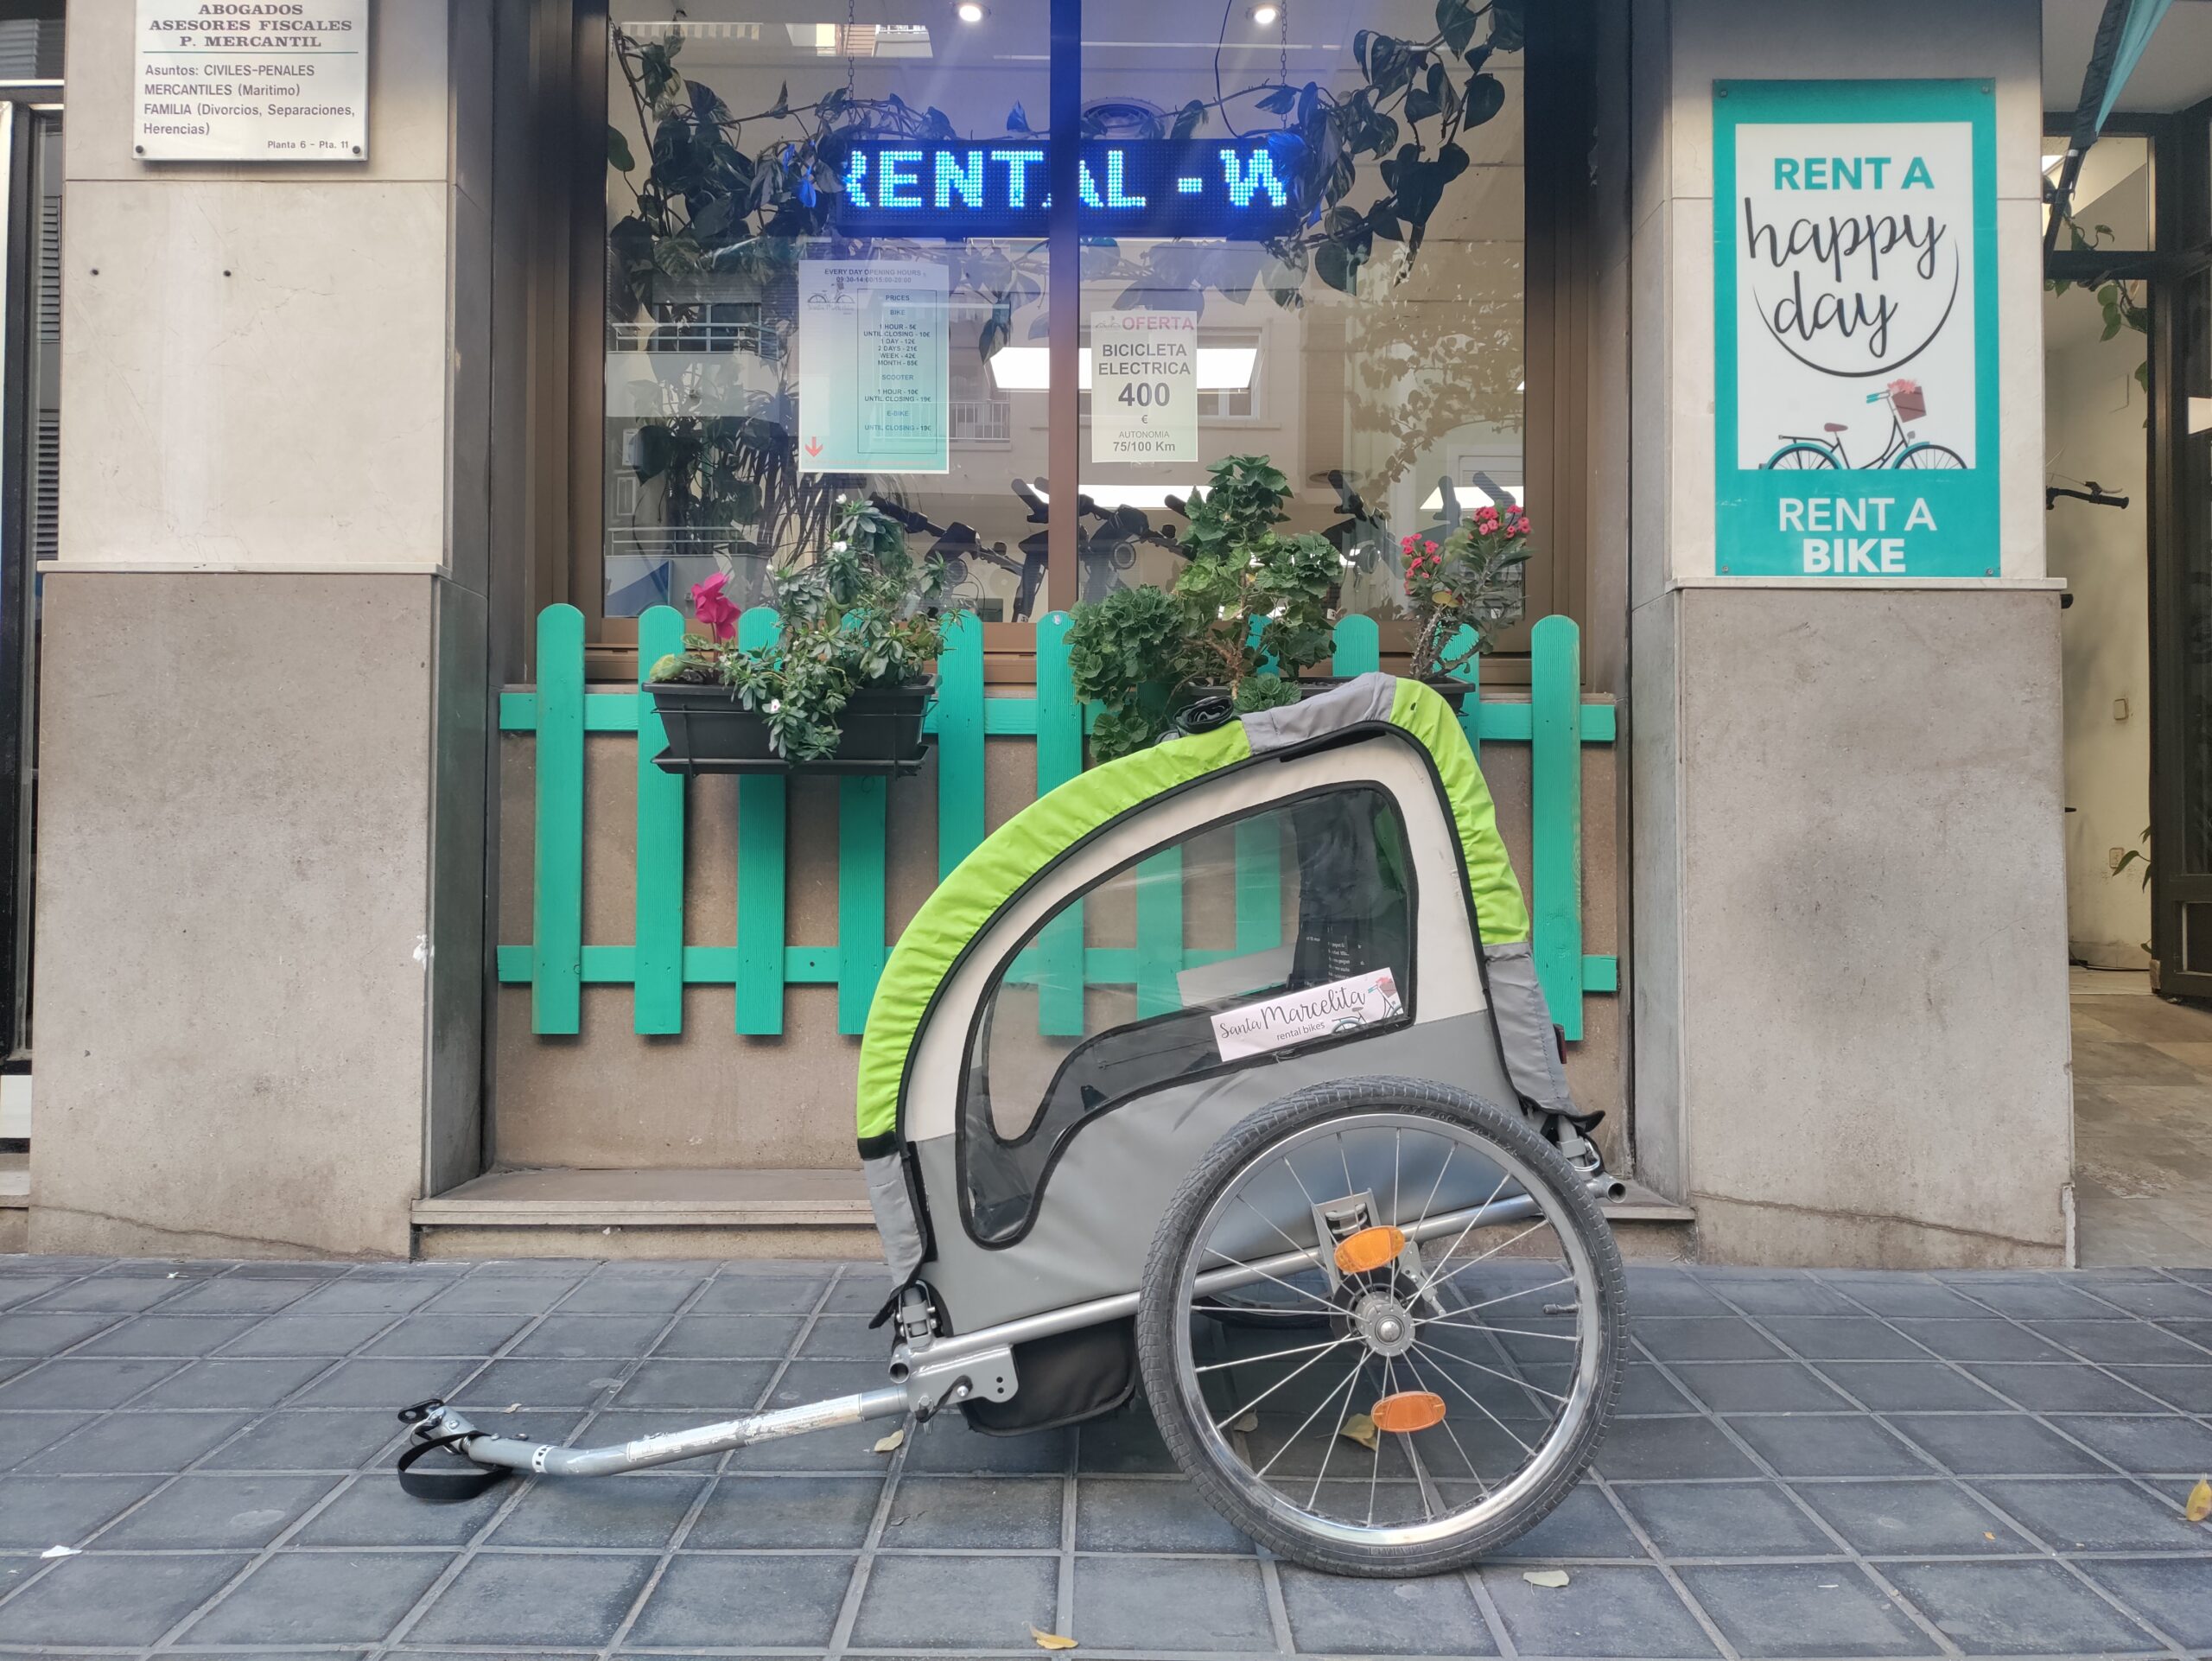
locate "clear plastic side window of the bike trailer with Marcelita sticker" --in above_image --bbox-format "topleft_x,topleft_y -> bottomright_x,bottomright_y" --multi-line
960,786 -> 1415,1243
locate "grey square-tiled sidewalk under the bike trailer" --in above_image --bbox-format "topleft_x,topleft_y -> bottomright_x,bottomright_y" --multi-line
0,1258 -> 2212,1657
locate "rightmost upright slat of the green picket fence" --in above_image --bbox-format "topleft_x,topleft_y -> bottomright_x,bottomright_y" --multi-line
1529,617 -> 1581,1037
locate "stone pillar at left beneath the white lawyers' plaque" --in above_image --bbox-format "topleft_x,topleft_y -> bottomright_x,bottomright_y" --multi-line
31,0 -> 493,1257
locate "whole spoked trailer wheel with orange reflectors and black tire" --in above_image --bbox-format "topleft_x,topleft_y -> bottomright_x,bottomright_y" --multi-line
1137,1079 -> 1626,1575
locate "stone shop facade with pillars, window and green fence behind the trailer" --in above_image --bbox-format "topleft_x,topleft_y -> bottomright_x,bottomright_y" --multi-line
11,0 -> 2212,1265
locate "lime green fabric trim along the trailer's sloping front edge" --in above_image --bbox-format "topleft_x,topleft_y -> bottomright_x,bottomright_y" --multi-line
858,725 -> 1256,1142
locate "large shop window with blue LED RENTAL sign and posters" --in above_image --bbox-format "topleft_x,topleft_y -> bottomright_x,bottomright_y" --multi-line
593,0 -> 1548,640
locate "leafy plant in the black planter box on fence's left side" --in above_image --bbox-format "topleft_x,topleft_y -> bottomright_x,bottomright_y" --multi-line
651,500 -> 944,760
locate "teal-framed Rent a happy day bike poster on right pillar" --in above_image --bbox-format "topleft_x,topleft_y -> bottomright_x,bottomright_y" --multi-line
1712,82 -> 2004,582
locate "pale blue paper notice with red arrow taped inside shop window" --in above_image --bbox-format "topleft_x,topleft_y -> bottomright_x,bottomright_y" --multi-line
798,258 -> 951,474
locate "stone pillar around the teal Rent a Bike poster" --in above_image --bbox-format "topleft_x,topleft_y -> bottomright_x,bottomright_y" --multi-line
1628,0 -> 2073,1265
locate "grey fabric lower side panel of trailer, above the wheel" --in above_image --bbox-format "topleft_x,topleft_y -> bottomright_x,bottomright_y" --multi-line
913,1011 -> 1516,1332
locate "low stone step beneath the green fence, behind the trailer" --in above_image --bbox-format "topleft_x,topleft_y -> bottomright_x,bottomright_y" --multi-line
414,1168 -> 1697,1258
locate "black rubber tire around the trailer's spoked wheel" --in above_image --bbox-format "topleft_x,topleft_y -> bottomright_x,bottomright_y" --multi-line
1137,1077 -> 1628,1579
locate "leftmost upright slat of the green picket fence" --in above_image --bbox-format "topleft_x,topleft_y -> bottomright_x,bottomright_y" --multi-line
531,606 -> 584,1033
